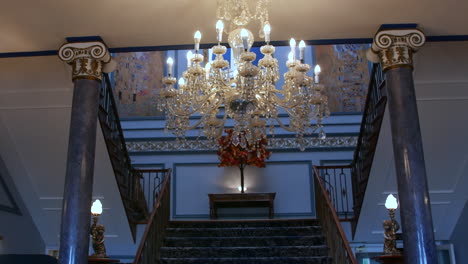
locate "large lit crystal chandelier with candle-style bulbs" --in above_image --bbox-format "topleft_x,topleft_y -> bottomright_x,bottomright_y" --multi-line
158,0 -> 330,150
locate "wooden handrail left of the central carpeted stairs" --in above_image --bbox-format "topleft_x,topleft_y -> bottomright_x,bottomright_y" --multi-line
133,169 -> 171,264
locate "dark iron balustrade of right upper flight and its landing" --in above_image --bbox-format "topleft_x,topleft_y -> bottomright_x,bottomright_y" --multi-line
317,64 -> 387,235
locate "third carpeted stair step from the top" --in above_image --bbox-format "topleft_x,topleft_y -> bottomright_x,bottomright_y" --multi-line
164,235 -> 325,247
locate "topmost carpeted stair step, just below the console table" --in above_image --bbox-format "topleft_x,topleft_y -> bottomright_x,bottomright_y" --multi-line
169,219 -> 320,228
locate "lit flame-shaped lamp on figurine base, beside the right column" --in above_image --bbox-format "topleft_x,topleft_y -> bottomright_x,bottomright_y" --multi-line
383,194 -> 401,255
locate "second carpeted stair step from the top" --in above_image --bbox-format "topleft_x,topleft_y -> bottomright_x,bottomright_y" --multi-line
166,226 -> 322,237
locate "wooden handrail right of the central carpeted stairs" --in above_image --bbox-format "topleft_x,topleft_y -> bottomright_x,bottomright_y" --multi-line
314,166 -> 357,264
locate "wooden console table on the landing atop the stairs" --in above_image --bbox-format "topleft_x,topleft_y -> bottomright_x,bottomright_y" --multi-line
208,193 -> 276,219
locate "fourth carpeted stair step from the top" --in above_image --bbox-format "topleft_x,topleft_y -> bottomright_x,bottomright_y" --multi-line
161,245 -> 328,258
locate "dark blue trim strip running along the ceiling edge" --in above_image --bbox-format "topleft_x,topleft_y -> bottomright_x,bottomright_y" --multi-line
0,35 -> 468,58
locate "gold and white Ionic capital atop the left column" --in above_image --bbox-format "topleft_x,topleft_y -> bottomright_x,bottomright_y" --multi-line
58,41 -> 112,81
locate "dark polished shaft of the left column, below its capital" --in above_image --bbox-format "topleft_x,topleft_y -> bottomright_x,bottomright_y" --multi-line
59,79 -> 100,264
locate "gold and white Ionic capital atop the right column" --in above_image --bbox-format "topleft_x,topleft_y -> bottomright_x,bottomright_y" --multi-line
367,29 -> 426,71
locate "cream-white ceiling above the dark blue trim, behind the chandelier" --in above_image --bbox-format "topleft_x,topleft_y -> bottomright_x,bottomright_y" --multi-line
0,0 -> 468,53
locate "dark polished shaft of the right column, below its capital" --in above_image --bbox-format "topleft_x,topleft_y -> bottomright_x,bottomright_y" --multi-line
385,67 -> 437,264
